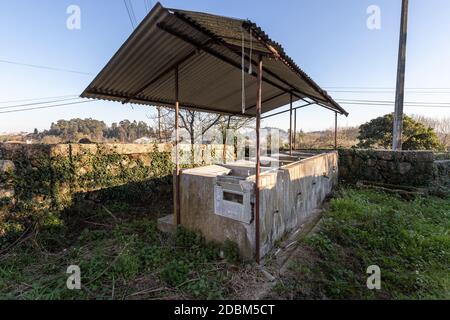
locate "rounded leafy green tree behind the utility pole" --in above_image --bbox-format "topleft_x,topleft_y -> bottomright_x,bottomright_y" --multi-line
357,113 -> 442,150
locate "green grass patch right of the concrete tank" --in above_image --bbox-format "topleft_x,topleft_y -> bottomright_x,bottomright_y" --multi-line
272,189 -> 450,299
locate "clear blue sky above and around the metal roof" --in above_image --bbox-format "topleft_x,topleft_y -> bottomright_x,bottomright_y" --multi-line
0,0 -> 450,132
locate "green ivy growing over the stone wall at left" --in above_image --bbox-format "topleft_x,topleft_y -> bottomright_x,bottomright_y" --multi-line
0,145 -> 173,250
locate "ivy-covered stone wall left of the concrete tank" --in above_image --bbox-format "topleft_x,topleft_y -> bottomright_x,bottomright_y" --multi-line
0,144 -> 173,228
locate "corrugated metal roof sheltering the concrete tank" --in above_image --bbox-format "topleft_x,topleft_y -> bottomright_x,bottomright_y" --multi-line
81,3 -> 347,116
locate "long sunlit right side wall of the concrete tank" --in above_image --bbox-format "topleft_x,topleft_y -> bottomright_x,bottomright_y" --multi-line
261,152 -> 338,256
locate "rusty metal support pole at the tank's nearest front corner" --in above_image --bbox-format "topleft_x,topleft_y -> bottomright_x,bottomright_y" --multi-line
255,56 -> 263,263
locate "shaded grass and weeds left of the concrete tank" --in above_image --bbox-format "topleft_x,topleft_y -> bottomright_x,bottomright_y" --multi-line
0,200 -> 243,299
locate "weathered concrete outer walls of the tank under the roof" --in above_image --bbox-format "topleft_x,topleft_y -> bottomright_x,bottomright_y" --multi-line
180,152 -> 338,260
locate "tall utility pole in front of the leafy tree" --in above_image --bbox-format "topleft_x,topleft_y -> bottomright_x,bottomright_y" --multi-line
392,0 -> 408,150
